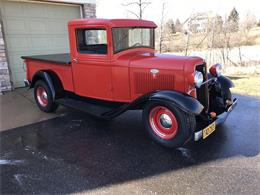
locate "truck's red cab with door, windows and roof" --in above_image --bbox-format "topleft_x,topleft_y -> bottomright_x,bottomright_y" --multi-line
68,19 -> 156,102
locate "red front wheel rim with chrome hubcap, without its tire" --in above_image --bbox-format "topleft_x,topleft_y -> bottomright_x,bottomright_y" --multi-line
149,106 -> 178,140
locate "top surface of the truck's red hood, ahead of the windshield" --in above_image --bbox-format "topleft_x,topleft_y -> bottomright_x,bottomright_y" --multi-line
129,53 -> 204,70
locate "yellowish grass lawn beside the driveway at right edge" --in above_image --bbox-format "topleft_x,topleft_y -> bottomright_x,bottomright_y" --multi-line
228,75 -> 260,96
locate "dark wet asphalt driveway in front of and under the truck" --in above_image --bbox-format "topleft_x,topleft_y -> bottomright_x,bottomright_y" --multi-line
0,96 -> 260,194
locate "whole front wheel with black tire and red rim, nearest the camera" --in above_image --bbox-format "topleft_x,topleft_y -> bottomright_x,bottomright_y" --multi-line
143,101 -> 196,148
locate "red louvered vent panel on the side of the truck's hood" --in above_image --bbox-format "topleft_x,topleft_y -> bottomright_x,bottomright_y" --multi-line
134,72 -> 174,94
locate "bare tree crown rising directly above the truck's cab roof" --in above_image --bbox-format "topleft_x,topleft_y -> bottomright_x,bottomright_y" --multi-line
123,0 -> 151,20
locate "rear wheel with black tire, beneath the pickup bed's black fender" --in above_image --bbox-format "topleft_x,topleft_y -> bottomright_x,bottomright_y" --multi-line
34,80 -> 59,113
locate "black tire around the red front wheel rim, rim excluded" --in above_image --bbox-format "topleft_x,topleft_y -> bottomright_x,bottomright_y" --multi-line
143,101 -> 196,148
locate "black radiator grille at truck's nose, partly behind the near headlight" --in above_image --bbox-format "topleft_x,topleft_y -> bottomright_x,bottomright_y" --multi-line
196,64 -> 209,110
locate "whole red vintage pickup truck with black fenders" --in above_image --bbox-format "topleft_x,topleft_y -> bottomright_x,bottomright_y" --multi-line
22,19 -> 237,148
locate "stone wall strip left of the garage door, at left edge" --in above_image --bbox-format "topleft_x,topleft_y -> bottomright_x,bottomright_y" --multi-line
0,21 -> 11,94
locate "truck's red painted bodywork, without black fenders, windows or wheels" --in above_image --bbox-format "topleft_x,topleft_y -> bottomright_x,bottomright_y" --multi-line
25,19 -> 204,102
